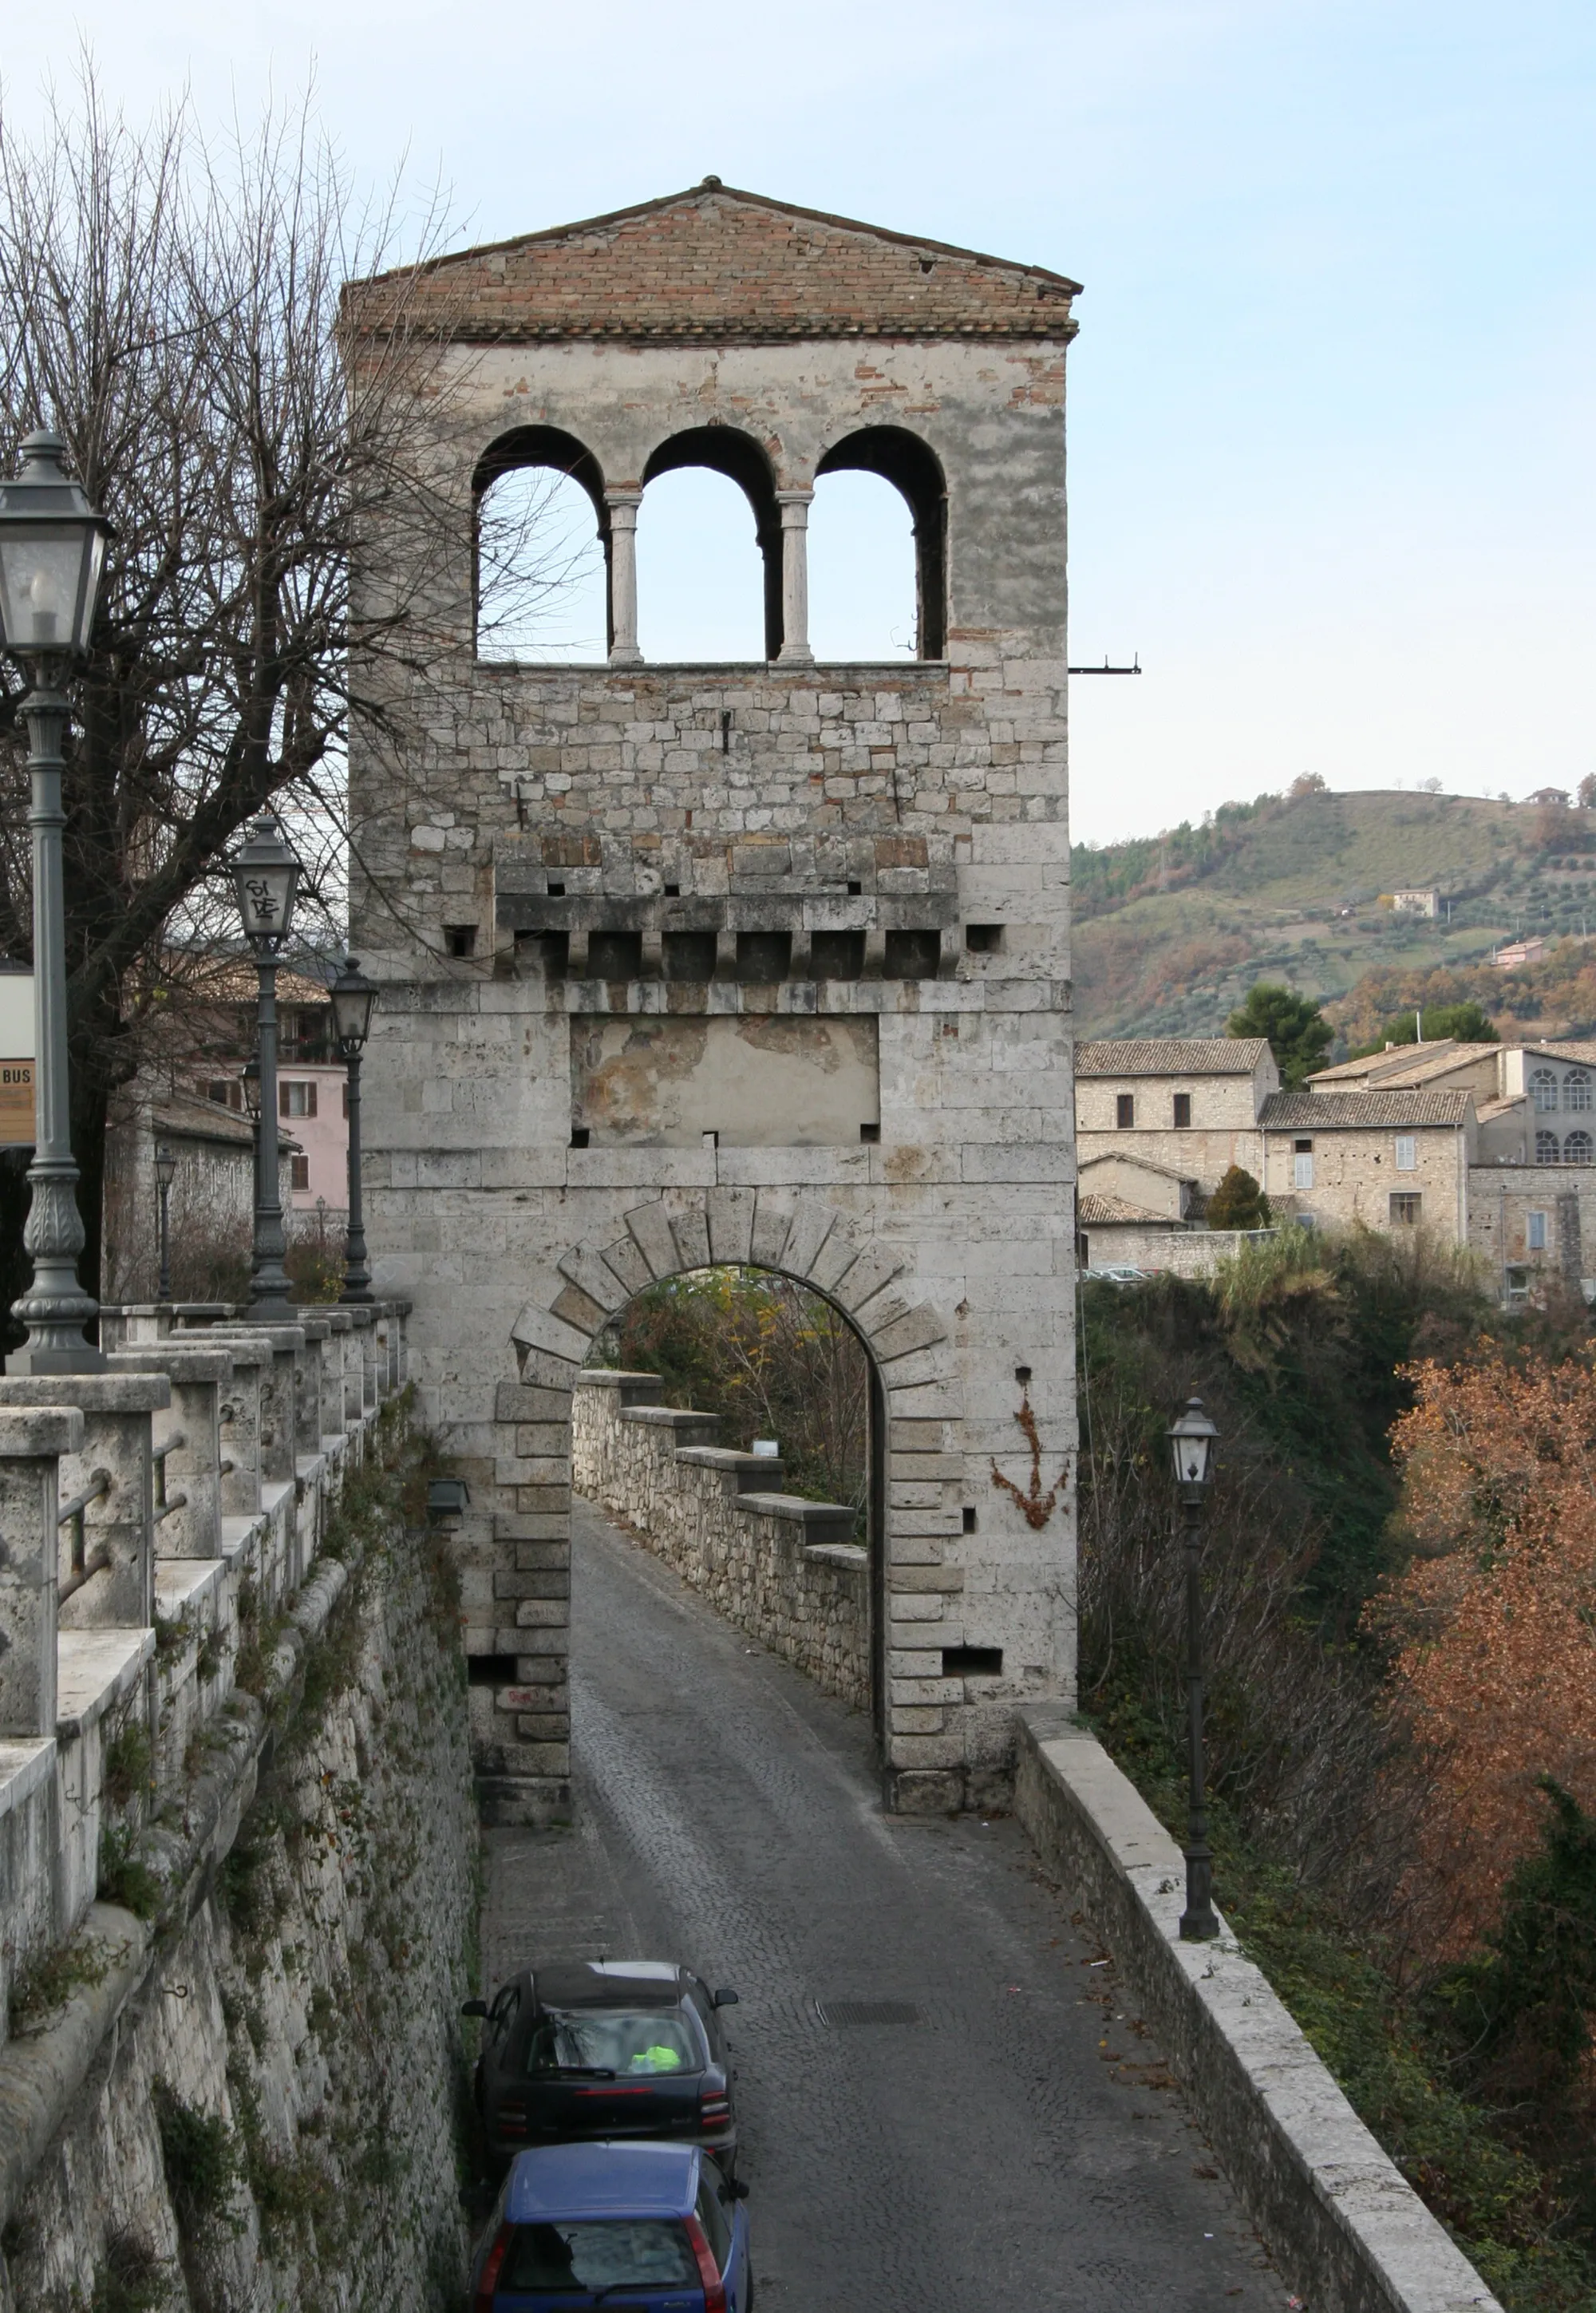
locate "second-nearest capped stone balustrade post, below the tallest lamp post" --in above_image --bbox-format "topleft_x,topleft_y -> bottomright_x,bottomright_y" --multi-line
0,1372 -> 171,1631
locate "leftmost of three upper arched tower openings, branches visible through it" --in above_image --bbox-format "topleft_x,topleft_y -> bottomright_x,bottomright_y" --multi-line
472,425 -> 610,666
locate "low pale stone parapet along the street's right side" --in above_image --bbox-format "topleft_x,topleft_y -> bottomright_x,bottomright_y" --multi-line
1015,1702 -> 1501,2313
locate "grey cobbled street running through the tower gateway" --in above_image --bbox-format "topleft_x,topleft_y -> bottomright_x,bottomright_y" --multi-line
484,1504 -> 1286,2313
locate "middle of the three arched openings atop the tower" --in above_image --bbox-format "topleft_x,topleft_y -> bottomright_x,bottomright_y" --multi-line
638,425 -> 782,662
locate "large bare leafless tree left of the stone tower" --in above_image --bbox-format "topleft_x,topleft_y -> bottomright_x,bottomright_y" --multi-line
0,69 -> 467,1307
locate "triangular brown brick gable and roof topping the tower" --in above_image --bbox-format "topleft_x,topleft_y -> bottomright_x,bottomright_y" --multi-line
345,176 -> 1080,345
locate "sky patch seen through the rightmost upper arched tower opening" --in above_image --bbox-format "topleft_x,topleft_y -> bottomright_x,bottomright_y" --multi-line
809,469 -> 918,662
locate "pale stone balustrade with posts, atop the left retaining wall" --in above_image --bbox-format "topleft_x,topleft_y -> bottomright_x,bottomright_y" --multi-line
0,1303 -> 409,2042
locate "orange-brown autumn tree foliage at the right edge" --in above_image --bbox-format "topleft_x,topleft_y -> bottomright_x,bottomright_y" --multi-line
1369,1358 -> 1596,1962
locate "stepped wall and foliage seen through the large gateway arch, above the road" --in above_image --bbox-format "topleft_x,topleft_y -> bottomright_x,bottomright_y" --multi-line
571,1263 -> 886,1739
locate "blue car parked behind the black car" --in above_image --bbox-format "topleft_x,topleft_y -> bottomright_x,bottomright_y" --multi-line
469,2137 -> 754,2313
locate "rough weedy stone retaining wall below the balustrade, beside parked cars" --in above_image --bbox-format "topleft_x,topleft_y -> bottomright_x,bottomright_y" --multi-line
0,1433 -> 476,2313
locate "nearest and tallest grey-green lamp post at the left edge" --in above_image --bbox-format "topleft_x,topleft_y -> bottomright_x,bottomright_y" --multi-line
0,433 -> 111,1374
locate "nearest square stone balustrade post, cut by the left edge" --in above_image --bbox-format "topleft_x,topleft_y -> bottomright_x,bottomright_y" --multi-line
0,1406 -> 83,1742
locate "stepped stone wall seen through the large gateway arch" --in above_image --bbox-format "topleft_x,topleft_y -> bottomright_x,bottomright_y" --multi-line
571,1372 -> 870,1710
